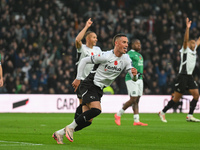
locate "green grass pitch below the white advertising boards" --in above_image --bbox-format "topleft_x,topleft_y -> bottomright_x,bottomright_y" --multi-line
0,113 -> 200,150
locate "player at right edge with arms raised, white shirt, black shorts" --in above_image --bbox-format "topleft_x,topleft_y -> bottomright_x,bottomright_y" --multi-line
158,18 -> 200,122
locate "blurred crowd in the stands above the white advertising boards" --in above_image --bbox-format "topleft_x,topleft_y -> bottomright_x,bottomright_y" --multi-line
0,0 -> 200,95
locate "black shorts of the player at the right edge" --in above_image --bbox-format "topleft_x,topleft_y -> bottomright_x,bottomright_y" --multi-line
175,74 -> 198,94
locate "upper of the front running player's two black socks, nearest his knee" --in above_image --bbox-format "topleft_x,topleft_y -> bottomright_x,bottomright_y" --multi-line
75,108 -> 101,125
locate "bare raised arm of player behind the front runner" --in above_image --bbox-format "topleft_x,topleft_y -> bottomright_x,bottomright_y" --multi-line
75,18 -> 93,49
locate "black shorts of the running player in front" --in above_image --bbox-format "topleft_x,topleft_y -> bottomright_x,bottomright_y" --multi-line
80,80 -> 103,105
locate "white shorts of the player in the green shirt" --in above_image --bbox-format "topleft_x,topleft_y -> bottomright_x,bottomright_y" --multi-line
126,79 -> 143,97
